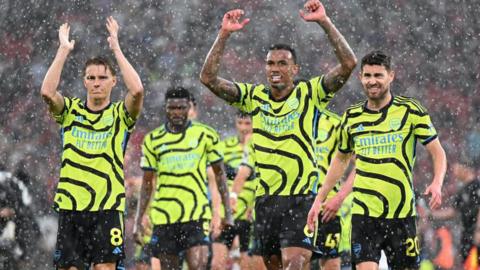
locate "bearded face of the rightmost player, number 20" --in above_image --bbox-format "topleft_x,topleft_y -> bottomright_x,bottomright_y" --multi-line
359,65 -> 395,102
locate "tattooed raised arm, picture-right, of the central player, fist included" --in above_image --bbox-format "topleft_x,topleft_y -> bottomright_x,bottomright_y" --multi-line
300,0 -> 357,92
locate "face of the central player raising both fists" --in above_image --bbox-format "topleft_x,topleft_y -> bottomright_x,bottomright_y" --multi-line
265,50 -> 299,91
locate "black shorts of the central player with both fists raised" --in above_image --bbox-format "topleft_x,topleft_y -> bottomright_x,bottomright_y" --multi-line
252,194 -> 316,257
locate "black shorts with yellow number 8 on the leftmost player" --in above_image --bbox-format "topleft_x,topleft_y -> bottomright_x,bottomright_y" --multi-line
54,210 -> 125,269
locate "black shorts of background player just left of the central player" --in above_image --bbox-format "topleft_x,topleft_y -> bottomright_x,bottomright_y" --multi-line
215,220 -> 252,252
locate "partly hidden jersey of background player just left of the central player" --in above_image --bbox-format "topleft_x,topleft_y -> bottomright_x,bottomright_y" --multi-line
222,136 -> 256,220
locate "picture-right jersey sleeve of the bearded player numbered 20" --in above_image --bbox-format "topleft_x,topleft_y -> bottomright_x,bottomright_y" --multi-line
410,100 -> 437,145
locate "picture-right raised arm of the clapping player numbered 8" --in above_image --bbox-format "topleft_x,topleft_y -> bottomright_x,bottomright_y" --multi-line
106,16 -> 144,119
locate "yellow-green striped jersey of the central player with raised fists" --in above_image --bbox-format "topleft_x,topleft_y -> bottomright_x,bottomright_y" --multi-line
232,77 -> 333,197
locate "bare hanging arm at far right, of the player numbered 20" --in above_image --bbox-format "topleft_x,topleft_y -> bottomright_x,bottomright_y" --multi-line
424,138 -> 447,210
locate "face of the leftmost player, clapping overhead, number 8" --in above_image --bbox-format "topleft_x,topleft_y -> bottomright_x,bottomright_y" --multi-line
83,65 -> 117,101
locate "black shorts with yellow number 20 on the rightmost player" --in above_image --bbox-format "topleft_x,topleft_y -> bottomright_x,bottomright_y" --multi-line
352,215 -> 420,269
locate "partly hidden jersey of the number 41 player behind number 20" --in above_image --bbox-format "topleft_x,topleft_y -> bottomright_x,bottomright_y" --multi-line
315,109 -> 341,199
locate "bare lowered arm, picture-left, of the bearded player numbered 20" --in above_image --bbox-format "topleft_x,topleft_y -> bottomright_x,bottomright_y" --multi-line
307,151 -> 351,232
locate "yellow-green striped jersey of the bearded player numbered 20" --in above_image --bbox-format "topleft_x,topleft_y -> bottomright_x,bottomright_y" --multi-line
339,96 -> 437,218
